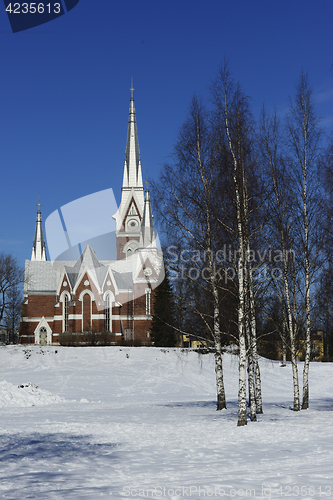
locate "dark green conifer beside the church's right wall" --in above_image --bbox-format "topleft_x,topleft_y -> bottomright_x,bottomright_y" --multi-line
150,269 -> 176,347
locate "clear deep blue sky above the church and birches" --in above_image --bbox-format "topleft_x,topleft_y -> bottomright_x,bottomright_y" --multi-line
0,0 -> 333,265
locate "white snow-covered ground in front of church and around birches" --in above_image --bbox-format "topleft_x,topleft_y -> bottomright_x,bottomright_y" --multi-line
0,346 -> 333,500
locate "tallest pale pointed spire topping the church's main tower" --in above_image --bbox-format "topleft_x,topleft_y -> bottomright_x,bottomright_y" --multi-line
123,78 -> 143,191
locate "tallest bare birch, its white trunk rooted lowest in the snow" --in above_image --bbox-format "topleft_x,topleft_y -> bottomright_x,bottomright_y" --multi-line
212,63 -> 262,426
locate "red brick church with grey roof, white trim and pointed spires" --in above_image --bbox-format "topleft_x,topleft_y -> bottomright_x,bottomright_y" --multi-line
19,89 -> 164,345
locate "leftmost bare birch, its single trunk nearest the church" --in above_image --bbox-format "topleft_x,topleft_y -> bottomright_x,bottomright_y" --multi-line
155,97 -> 226,410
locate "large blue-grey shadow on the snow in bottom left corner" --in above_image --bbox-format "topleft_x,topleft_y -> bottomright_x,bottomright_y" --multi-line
0,433 -> 132,500
